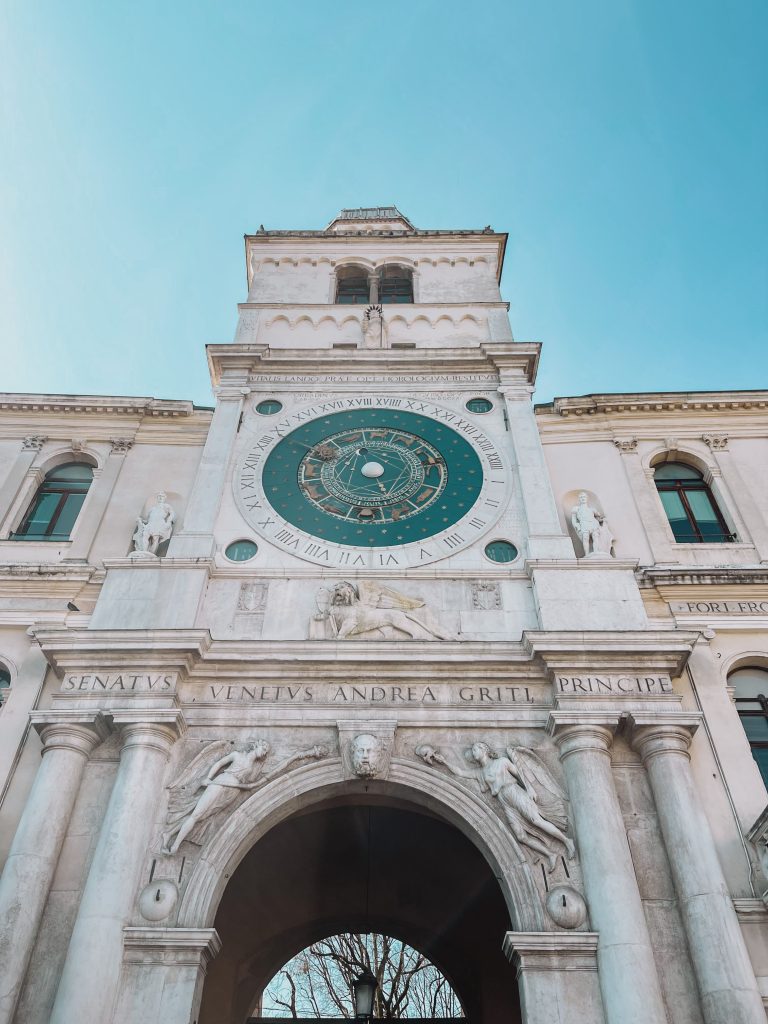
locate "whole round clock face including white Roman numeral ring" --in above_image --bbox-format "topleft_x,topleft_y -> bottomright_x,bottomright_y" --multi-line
236,398 -> 506,567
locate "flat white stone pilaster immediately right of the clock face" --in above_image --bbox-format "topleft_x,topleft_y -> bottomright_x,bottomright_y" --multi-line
499,384 -> 575,560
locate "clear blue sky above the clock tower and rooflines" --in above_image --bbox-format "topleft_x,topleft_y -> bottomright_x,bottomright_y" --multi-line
0,0 -> 768,404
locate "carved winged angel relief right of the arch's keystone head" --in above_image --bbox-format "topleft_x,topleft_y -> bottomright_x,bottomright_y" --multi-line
416,741 -> 575,871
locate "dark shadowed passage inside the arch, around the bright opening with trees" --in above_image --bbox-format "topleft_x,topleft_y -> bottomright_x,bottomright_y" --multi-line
200,795 -> 520,1024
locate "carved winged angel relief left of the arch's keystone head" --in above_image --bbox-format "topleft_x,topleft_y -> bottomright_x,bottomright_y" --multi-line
163,739 -> 329,854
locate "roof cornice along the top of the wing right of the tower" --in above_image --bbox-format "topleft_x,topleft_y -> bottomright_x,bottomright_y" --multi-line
534,390 -> 768,417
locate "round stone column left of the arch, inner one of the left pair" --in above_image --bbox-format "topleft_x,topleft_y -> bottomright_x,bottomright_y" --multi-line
50,709 -> 183,1024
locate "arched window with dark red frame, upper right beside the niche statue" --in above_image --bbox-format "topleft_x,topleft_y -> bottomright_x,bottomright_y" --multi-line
653,462 -> 735,544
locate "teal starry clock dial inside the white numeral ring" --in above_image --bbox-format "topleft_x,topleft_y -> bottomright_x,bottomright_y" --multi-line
261,409 -> 483,548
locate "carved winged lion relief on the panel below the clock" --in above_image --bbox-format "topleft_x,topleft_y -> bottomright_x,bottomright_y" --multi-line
310,580 -> 457,640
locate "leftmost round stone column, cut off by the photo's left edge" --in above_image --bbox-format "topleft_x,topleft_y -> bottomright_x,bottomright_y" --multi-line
0,711 -> 109,1024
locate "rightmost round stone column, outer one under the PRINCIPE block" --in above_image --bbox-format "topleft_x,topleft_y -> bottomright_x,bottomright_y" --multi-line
632,715 -> 765,1024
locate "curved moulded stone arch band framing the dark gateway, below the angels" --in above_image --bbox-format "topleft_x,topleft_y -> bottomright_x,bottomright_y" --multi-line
177,758 -> 548,932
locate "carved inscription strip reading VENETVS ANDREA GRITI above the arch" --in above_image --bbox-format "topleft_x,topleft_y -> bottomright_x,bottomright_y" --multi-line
202,683 -> 549,707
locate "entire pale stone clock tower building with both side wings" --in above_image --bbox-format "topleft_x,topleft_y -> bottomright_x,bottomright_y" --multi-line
0,208 -> 768,1024
